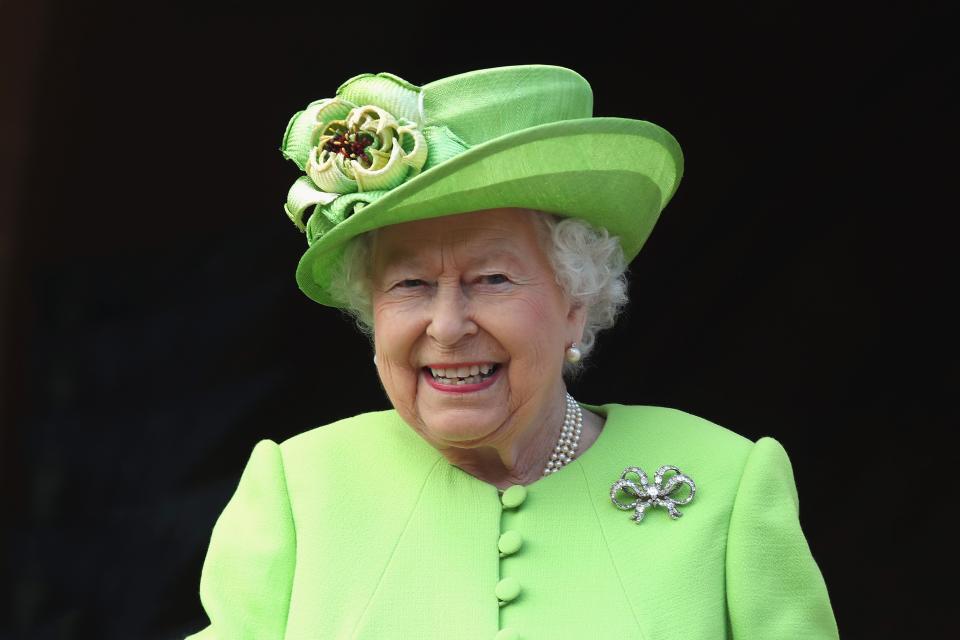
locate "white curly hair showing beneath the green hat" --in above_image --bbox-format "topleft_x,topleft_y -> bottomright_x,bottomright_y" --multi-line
329,209 -> 628,377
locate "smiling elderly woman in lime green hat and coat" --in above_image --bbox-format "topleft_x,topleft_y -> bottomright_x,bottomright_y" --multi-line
184,65 -> 838,640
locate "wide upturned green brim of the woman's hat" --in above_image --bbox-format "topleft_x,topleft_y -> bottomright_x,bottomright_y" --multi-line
296,117 -> 683,307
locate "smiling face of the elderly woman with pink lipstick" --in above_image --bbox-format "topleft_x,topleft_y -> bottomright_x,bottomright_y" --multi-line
371,208 -> 585,456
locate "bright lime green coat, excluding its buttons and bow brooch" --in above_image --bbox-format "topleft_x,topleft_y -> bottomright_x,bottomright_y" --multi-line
184,404 -> 838,640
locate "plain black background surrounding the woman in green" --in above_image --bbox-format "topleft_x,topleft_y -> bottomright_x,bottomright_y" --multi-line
0,0 -> 948,639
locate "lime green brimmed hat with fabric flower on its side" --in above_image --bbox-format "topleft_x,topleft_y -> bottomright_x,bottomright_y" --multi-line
280,64 -> 683,307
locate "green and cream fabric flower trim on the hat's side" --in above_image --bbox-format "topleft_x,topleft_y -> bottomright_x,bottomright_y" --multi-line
280,73 -> 429,238
